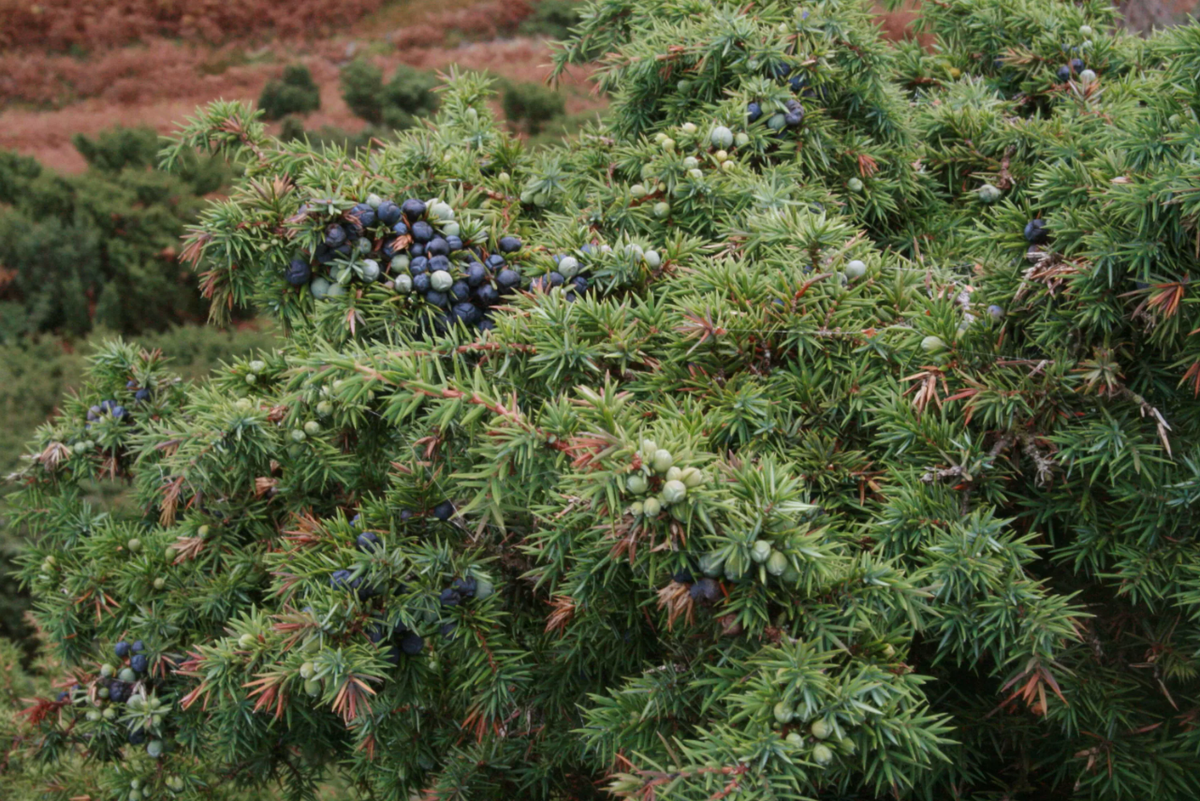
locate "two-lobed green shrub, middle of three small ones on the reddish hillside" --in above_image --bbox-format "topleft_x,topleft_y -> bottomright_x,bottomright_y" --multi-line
341,59 -> 438,131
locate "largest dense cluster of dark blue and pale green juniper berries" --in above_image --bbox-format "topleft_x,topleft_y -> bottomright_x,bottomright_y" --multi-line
286,195 -> 522,331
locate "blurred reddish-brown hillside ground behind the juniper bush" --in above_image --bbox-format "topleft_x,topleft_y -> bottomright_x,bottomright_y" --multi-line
0,0 -> 1198,171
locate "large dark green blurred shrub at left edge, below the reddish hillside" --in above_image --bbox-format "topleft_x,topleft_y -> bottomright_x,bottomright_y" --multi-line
0,128 -> 230,342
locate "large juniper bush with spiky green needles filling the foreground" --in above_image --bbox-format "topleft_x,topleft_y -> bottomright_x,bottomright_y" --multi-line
4,0 -> 1200,801
